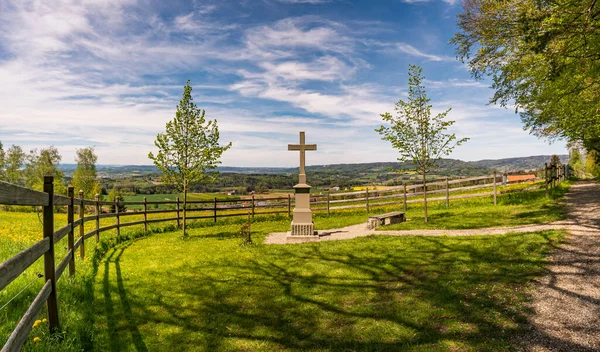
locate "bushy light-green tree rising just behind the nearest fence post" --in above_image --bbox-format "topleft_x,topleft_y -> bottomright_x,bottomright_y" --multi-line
25,146 -> 67,194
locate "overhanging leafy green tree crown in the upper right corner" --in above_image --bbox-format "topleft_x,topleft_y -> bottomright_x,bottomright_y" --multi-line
451,0 -> 600,151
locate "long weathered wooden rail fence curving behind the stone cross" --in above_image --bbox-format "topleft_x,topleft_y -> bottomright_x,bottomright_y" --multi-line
0,173 -> 536,352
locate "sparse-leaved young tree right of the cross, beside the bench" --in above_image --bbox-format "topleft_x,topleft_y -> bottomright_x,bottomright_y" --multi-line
375,65 -> 468,223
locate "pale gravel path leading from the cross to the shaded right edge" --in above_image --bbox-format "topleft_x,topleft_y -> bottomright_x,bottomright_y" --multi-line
265,182 -> 600,352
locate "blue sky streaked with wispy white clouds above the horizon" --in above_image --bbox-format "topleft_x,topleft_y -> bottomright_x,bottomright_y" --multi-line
0,0 -> 565,166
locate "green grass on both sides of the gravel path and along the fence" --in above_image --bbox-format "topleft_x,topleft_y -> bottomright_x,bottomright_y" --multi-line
0,183 -> 566,351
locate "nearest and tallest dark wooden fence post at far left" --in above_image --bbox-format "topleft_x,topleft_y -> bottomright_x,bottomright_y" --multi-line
43,176 -> 59,332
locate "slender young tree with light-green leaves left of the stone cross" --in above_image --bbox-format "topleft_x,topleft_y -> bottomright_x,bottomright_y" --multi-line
148,80 -> 231,236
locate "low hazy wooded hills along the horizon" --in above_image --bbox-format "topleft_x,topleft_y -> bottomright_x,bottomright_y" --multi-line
59,155 -> 569,177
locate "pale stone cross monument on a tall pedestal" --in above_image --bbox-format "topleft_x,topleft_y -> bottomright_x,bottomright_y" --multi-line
288,132 -> 318,240
